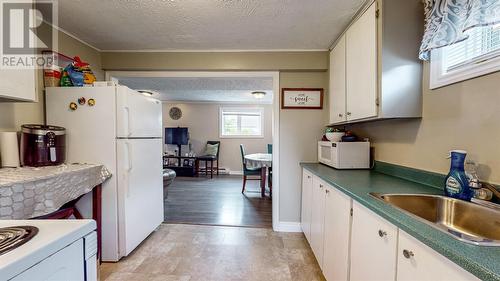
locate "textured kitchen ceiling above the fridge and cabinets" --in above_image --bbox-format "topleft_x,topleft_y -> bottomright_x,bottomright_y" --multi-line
53,0 -> 364,50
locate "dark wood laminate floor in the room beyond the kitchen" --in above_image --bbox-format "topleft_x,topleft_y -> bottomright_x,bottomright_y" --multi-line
165,175 -> 272,227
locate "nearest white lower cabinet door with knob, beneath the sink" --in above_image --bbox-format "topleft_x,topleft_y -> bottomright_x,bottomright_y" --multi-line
397,230 -> 479,281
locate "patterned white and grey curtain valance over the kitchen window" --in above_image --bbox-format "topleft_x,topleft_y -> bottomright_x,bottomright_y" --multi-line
419,0 -> 500,60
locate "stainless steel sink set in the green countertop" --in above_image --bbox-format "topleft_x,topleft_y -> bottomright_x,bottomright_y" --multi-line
370,193 -> 500,246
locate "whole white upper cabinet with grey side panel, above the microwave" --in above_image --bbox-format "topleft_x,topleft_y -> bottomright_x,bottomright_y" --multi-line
329,0 -> 423,124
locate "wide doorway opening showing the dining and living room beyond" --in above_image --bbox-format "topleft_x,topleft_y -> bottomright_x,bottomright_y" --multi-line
106,71 -> 279,228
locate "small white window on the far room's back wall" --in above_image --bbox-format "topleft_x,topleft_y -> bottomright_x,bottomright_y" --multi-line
219,107 -> 264,138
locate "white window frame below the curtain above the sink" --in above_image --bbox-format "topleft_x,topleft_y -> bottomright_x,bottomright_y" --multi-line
429,27 -> 500,89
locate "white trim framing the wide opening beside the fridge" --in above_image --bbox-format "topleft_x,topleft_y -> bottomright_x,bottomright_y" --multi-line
105,71 -> 280,231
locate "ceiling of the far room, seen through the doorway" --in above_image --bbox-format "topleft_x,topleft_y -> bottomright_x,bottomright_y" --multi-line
118,77 -> 273,104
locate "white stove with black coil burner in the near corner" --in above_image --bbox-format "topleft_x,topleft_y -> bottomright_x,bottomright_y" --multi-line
0,220 -> 97,281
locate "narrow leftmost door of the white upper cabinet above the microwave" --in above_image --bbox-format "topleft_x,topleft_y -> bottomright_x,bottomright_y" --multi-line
329,35 -> 347,123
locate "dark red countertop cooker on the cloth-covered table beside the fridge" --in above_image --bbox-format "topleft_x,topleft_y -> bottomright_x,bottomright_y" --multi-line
21,124 -> 66,167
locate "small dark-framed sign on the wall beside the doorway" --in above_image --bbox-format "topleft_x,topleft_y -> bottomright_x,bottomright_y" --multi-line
281,88 -> 323,109
